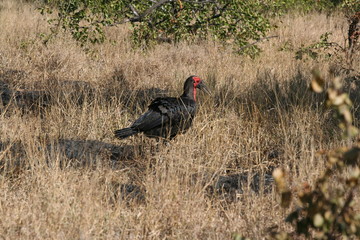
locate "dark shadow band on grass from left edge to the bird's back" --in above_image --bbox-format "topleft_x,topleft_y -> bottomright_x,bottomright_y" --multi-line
0,69 -> 169,113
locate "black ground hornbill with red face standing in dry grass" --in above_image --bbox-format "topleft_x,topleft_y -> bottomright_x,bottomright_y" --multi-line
115,76 -> 210,139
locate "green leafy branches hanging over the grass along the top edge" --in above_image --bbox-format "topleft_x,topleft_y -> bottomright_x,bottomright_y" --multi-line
40,0 -> 271,52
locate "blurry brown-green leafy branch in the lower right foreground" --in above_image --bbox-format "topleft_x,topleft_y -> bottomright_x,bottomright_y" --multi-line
271,72 -> 360,240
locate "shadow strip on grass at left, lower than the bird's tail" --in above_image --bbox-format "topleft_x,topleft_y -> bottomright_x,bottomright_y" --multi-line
0,139 -> 143,170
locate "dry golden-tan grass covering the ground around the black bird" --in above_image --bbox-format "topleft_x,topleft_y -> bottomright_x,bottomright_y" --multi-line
0,0 -> 359,239
